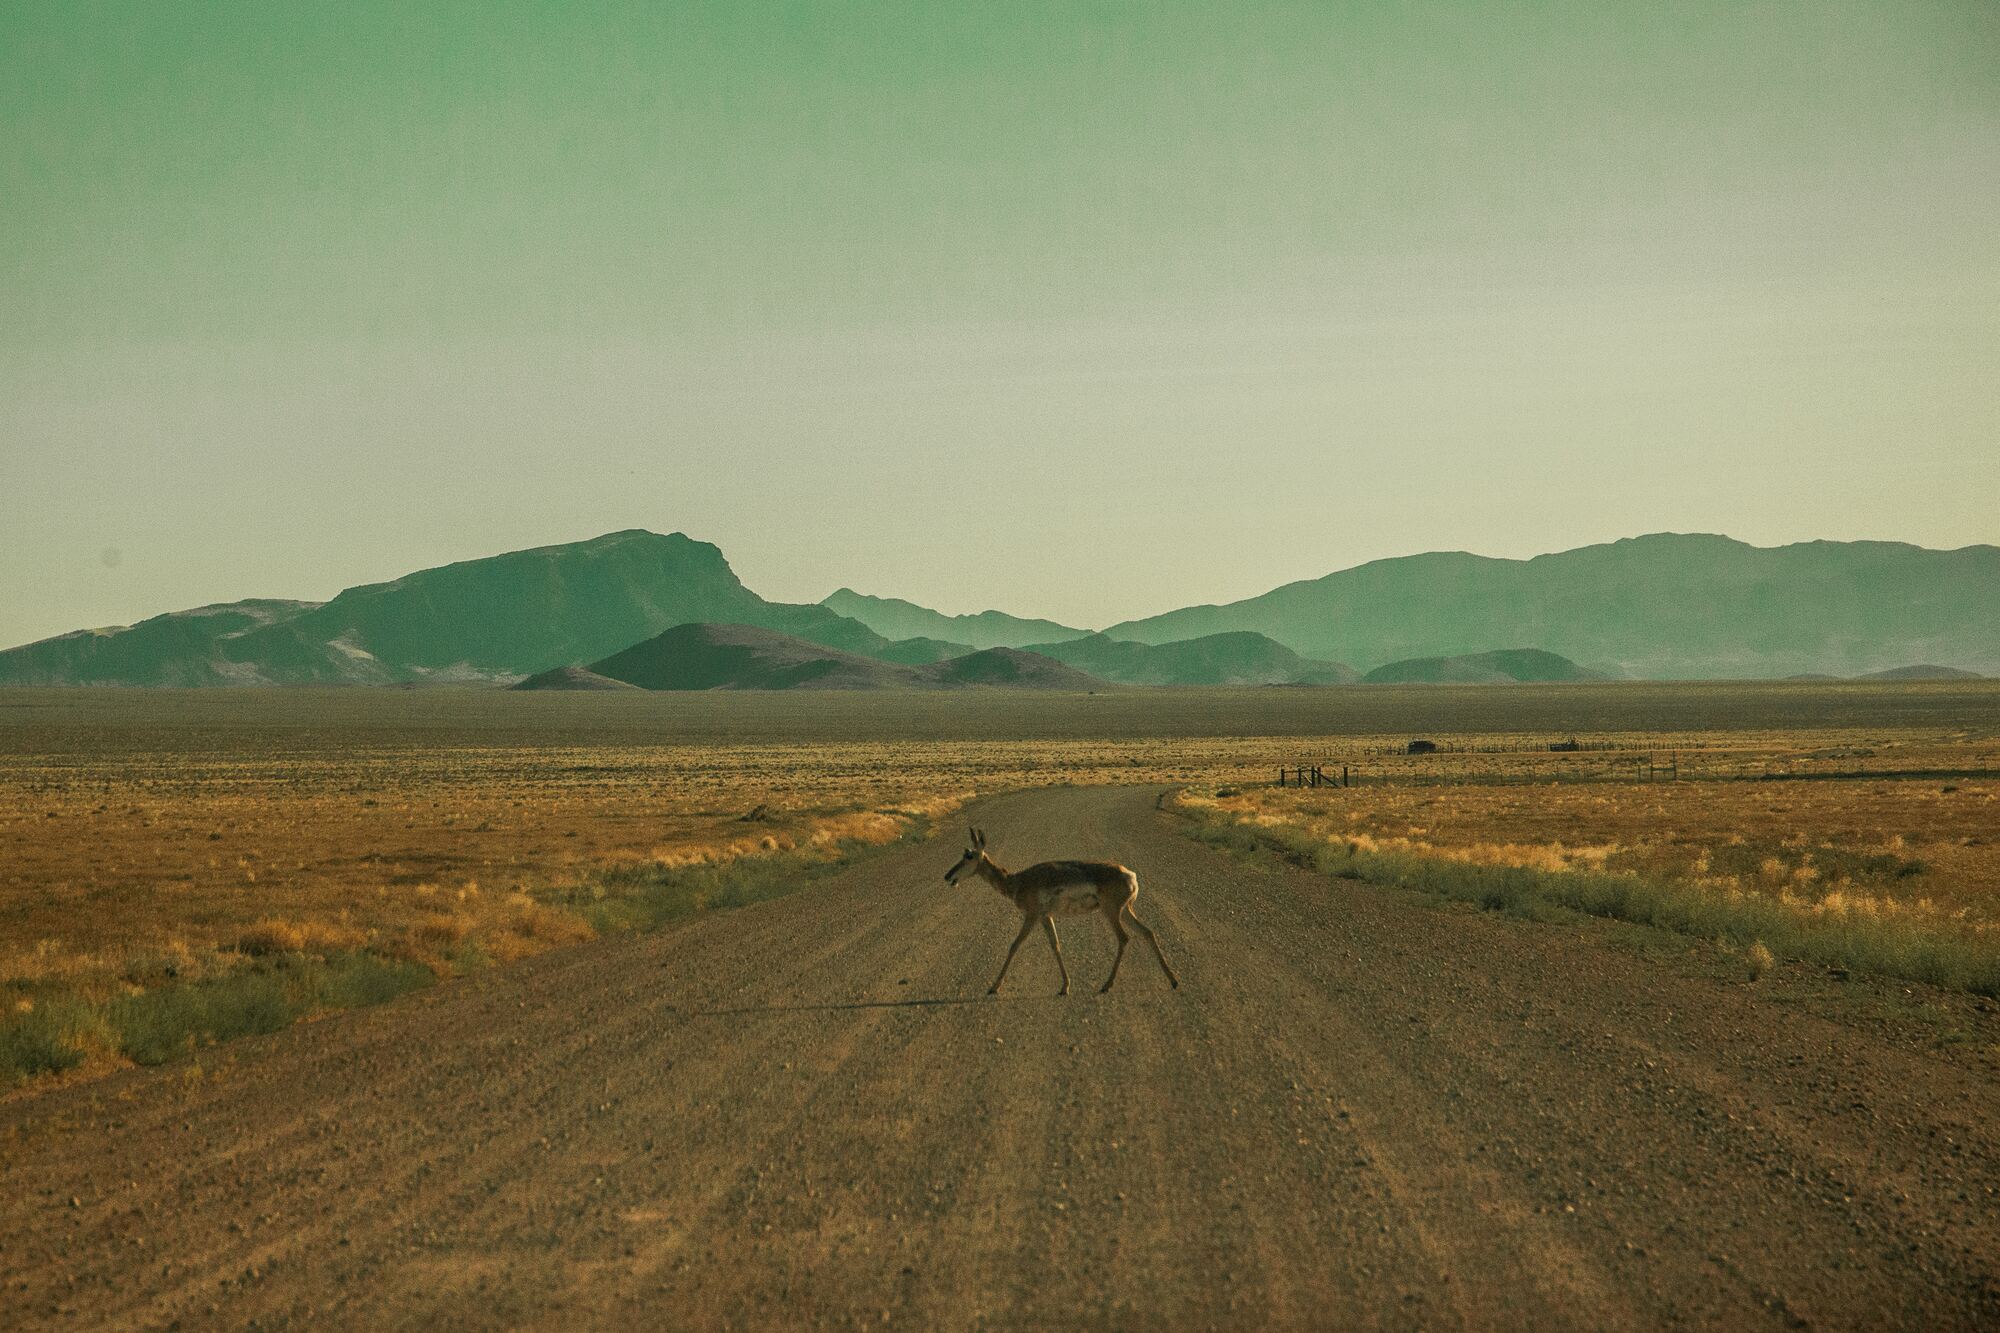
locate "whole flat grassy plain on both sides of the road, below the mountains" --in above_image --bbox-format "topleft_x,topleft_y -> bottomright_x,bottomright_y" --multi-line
0,683 -> 2000,1079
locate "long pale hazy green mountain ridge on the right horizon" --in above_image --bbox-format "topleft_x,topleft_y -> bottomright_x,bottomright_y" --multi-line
1106,534 -> 2000,679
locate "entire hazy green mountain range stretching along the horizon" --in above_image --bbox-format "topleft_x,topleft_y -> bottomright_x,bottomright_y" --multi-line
0,530 -> 2000,689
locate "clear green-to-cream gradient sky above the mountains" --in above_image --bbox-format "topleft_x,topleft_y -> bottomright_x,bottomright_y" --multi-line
0,0 -> 2000,644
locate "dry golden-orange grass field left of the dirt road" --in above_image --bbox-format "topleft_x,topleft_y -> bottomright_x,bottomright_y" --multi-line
0,751 -> 964,991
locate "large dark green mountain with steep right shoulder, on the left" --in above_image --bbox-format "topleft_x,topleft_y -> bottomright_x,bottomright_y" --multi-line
0,530 -> 888,685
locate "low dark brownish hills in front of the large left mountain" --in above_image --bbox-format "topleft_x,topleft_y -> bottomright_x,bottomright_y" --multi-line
590,624 -> 1104,691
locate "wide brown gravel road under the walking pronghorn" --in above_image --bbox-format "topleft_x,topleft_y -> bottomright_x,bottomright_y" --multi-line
0,789 -> 2000,1329
